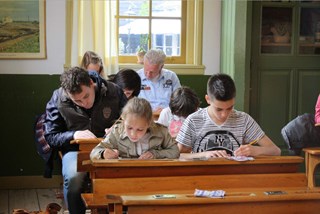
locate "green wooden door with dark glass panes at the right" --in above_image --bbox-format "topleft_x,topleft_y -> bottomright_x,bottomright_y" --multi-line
250,1 -> 320,154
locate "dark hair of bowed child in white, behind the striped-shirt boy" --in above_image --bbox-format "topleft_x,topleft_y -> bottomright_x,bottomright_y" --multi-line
169,86 -> 200,118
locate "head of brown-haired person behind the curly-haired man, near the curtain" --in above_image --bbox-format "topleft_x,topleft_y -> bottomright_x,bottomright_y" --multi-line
80,51 -> 105,78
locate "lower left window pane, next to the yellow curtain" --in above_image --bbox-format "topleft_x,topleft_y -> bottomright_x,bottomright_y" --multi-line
118,19 -> 149,55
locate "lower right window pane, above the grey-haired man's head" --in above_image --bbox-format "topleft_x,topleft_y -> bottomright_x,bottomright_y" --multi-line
151,19 -> 181,56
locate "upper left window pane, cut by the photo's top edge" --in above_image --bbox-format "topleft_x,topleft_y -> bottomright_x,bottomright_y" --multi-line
119,0 -> 149,16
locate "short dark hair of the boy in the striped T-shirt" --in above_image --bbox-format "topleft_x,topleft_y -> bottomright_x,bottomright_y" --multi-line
207,74 -> 236,101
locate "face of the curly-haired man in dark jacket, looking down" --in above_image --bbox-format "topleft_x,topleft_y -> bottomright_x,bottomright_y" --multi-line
68,80 -> 95,109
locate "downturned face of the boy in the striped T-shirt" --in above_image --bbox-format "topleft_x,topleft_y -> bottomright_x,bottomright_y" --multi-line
205,95 -> 235,125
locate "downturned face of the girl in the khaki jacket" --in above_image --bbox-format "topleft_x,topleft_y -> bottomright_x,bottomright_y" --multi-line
124,114 -> 150,142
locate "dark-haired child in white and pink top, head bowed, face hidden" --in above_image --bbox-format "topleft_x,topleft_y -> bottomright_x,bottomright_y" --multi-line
157,86 -> 200,138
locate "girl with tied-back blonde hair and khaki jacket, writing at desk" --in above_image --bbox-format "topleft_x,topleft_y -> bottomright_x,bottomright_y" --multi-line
90,97 -> 179,159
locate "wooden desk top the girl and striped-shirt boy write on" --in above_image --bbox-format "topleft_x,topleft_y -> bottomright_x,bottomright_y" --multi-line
83,156 -> 304,179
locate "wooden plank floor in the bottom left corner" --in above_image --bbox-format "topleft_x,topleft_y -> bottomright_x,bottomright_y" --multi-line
0,189 -> 69,214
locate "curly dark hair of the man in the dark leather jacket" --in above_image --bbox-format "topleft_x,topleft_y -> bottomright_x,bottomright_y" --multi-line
60,66 -> 91,94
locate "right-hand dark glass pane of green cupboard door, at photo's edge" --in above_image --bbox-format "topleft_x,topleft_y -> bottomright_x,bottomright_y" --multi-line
299,8 -> 320,54
